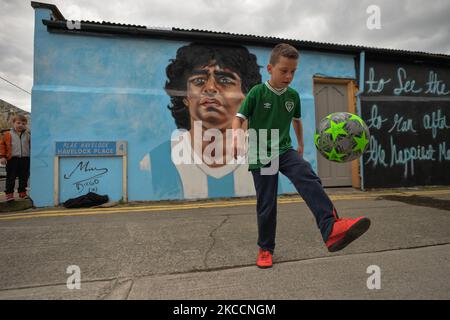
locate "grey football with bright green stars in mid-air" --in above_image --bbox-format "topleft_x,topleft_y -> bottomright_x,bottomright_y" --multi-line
314,112 -> 370,162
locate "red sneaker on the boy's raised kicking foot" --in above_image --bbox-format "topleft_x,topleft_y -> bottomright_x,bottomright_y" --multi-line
326,217 -> 370,252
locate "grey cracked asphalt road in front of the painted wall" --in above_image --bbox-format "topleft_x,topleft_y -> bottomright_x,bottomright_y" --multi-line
0,188 -> 450,299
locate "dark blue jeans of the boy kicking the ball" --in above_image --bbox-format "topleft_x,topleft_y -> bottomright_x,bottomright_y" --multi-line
251,149 -> 337,254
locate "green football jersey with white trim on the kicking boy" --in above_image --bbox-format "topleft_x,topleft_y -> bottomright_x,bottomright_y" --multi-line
237,81 -> 301,170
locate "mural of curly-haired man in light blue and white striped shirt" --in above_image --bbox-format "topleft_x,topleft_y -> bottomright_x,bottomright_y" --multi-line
150,43 -> 261,199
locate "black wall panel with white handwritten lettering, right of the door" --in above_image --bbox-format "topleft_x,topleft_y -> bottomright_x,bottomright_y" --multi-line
361,60 -> 450,188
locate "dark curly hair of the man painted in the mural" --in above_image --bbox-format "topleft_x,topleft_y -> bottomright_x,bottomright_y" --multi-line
164,43 -> 261,130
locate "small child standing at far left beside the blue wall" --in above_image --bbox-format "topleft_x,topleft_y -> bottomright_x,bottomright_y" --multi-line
0,115 -> 30,201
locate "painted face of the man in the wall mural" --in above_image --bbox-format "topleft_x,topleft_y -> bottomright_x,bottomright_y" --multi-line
183,61 -> 245,130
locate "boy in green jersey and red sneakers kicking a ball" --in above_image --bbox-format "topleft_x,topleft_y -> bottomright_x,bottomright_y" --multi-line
232,44 -> 370,268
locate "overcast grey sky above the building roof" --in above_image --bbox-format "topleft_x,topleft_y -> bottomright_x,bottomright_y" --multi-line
0,0 -> 450,111
